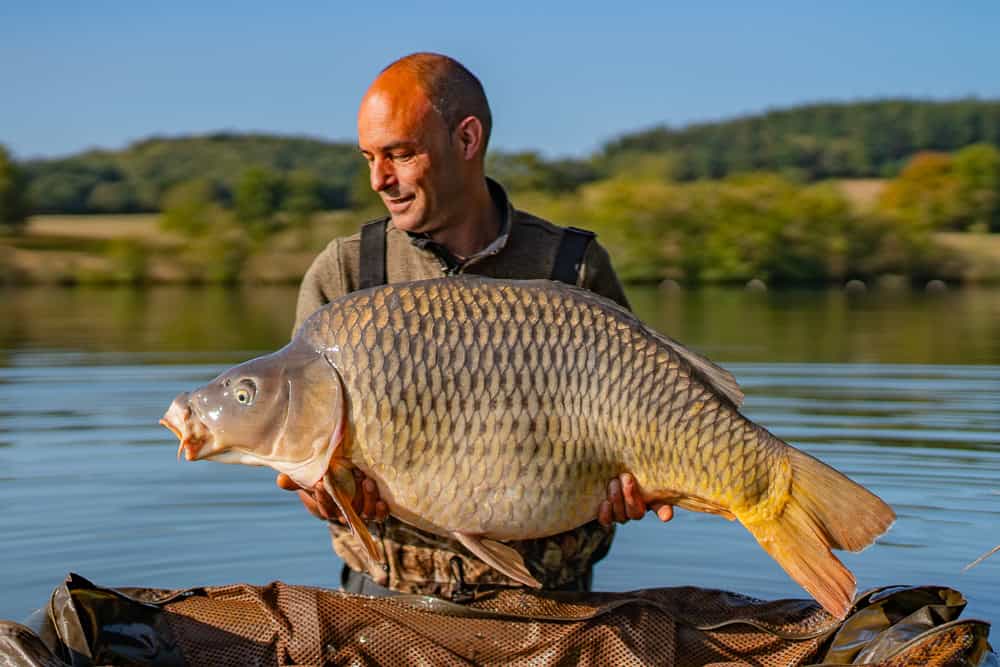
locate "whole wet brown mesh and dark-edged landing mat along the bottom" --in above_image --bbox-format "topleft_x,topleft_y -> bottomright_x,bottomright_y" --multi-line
0,575 -> 997,667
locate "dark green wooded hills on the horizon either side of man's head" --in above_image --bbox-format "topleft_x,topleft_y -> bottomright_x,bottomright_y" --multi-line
3,99 -> 1000,213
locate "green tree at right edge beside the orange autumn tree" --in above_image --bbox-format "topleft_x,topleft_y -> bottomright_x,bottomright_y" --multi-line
952,144 -> 1000,231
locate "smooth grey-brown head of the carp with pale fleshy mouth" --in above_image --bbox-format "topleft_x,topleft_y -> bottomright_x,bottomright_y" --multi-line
160,343 -> 346,486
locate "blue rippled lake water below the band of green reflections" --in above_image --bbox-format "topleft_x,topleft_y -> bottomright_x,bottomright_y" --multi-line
0,351 -> 1000,619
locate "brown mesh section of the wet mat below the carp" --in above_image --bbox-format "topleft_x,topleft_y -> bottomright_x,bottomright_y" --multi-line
158,583 -> 838,666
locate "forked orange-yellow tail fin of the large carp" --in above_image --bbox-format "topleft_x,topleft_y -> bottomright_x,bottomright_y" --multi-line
745,448 -> 896,618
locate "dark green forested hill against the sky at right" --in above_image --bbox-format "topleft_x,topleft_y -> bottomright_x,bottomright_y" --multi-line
602,99 -> 1000,181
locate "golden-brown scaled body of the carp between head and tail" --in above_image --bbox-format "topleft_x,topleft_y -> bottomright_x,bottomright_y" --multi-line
304,281 -> 764,539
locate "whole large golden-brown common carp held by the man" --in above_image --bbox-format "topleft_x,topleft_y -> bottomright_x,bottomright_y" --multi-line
161,277 -> 895,616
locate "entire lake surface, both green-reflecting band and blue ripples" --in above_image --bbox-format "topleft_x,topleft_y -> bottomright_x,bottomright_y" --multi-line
0,288 -> 1000,621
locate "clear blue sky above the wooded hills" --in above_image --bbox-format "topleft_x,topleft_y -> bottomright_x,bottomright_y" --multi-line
0,0 -> 1000,158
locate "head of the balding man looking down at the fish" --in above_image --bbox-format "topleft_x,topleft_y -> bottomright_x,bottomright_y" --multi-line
358,53 -> 492,232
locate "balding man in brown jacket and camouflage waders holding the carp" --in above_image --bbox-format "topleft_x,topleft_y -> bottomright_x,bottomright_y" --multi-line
278,53 -> 672,598
